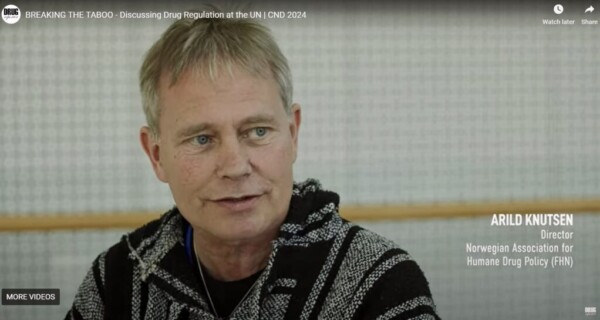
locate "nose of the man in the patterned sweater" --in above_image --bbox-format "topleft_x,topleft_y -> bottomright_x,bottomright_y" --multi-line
217,138 -> 252,179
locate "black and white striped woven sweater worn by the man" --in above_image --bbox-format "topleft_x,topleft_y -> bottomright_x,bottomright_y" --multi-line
67,180 -> 439,320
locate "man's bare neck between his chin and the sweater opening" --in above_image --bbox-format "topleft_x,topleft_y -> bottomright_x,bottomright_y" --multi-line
194,229 -> 275,281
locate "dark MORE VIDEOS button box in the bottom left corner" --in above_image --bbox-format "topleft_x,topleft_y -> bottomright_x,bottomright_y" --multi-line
2,289 -> 60,306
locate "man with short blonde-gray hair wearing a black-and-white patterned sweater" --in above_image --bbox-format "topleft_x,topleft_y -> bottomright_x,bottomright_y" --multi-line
67,10 -> 438,319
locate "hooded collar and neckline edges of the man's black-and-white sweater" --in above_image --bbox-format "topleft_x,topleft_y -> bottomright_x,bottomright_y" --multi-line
125,179 -> 342,315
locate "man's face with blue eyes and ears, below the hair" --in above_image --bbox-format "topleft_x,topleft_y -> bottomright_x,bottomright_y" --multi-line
141,69 -> 300,241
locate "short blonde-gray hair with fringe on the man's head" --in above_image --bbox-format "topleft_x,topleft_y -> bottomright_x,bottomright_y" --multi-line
140,10 -> 293,137
